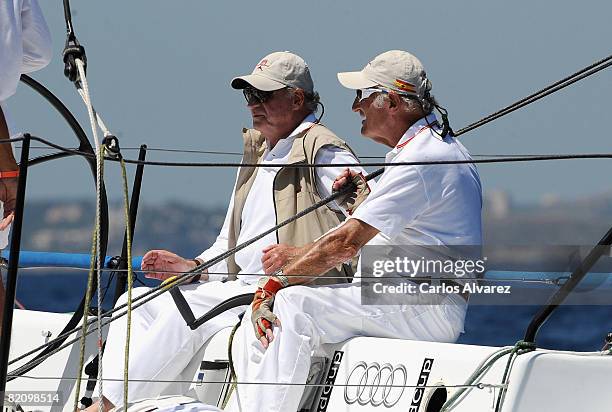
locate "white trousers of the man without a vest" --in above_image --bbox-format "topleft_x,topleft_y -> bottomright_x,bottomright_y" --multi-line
228,283 -> 467,412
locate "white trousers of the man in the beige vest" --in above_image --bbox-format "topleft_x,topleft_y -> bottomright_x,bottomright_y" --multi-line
101,280 -> 257,407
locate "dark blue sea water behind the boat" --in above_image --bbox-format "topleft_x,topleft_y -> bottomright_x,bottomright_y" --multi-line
10,270 -> 612,351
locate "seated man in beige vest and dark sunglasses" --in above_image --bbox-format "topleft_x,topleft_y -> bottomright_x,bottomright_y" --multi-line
85,52 -> 363,410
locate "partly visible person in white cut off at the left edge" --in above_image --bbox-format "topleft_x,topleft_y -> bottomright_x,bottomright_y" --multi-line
0,0 -> 51,325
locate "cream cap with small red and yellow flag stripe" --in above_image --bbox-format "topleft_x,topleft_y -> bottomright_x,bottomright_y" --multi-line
338,50 -> 431,98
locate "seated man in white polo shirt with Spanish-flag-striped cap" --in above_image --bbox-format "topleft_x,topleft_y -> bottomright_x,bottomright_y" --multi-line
231,50 -> 482,412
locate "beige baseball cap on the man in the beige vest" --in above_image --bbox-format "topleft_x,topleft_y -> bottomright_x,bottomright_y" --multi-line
231,51 -> 314,94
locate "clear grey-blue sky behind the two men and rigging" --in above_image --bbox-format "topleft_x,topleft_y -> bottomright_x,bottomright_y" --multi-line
9,0 -> 612,206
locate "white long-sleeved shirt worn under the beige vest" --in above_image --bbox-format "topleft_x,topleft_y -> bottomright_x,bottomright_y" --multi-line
198,114 -> 365,283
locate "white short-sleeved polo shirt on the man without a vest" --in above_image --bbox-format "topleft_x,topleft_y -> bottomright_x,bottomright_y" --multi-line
351,114 -> 482,249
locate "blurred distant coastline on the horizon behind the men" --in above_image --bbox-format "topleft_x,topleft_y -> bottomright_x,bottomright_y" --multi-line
22,190 -> 612,256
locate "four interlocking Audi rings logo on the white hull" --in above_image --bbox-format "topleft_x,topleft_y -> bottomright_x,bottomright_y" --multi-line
344,361 -> 408,408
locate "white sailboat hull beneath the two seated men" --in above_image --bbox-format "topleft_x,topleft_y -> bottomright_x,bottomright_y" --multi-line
7,310 -> 612,412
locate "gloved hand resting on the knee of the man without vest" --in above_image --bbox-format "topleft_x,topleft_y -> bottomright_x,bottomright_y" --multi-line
251,276 -> 287,349
